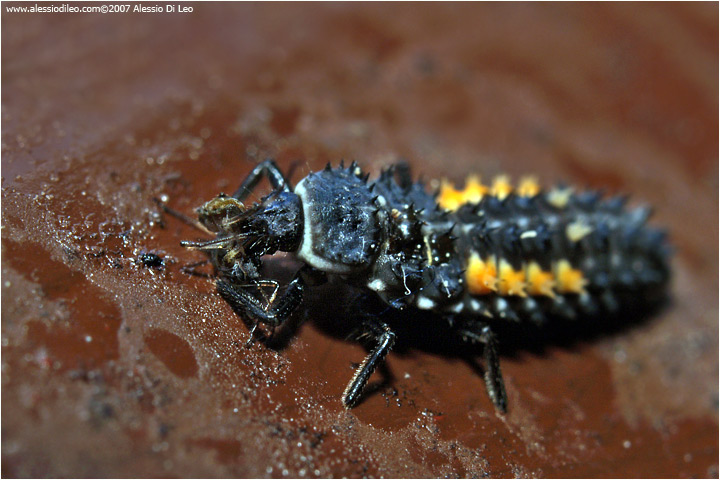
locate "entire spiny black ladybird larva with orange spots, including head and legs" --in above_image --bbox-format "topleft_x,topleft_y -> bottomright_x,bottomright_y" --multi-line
183,160 -> 669,411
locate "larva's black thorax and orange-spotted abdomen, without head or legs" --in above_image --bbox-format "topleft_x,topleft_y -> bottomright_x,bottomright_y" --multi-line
295,166 -> 668,322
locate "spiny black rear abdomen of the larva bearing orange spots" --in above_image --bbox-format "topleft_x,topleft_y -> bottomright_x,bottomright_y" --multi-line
438,176 -> 669,321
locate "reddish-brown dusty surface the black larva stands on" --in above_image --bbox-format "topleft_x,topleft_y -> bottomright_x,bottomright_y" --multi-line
2,3 -> 718,477
